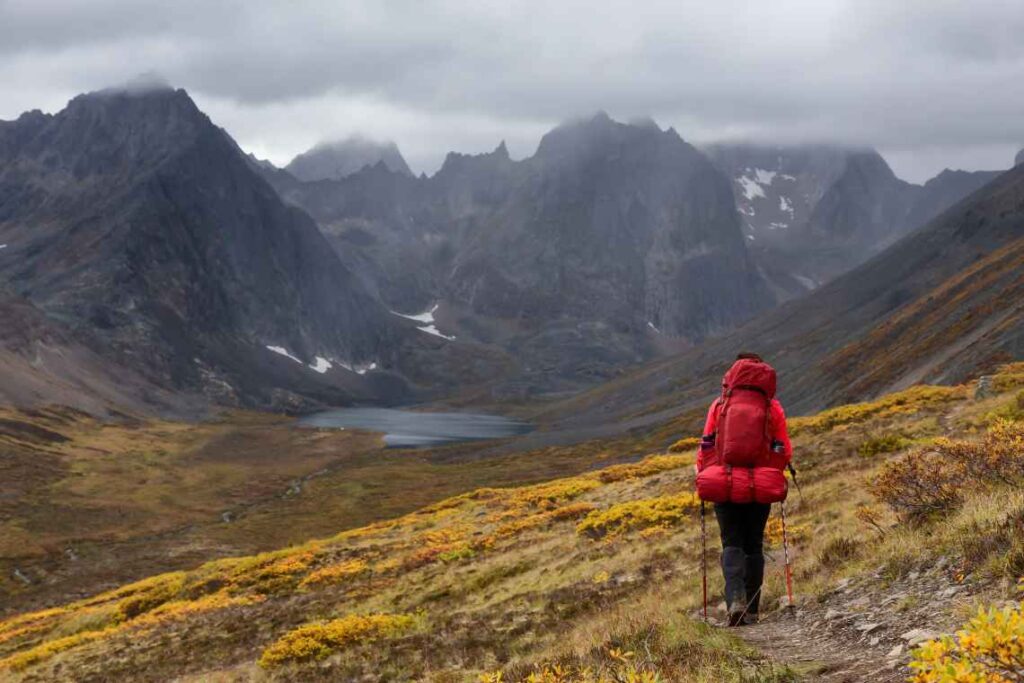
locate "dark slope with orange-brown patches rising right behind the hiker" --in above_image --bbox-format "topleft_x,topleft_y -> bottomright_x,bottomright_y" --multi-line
549,166 -> 1024,423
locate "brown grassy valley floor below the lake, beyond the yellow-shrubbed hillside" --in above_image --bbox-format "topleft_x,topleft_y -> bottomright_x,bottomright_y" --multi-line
0,408 -> 699,617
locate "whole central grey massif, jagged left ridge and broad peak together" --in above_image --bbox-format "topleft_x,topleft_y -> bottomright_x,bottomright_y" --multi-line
265,114 -> 774,391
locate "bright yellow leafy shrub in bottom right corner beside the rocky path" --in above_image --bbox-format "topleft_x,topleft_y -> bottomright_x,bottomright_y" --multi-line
910,604 -> 1024,683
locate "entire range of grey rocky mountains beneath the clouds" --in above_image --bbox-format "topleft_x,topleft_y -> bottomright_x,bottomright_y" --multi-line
0,87 -> 1005,411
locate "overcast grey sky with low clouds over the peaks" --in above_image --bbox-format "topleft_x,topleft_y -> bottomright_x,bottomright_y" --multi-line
0,0 -> 1024,181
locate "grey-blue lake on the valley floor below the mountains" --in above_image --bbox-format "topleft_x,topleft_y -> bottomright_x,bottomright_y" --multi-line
299,408 -> 532,447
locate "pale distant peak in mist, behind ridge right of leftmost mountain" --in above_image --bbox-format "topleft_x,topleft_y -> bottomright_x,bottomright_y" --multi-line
285,136 -> 413,181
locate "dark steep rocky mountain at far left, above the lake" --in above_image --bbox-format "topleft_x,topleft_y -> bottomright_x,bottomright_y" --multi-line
0,89 -> 400,403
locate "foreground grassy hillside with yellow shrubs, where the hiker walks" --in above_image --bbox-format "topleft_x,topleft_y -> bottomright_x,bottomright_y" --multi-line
0,365 -> 1024,682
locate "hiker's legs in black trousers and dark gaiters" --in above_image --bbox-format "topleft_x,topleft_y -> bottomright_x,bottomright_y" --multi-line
715,503 -> 771,614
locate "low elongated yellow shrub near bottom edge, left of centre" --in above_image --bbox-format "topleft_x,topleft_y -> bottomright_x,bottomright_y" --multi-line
259,614 -> 416,669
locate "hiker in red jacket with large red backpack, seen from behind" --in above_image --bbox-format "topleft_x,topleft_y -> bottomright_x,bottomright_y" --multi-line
696,352 -> 793,626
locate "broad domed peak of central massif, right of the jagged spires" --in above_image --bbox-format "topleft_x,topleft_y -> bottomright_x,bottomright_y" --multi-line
451,115 -> 772,340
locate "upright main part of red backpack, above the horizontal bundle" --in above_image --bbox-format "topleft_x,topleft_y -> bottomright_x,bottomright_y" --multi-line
715,359 -> 776,467
